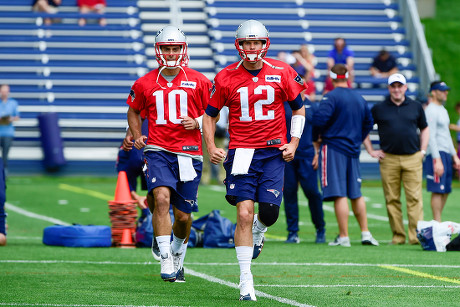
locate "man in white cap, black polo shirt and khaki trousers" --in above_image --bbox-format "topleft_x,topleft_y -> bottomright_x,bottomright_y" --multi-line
364,73 -> 429,244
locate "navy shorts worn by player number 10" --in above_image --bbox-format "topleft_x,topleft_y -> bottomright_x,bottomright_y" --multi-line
144,151 -> 203,213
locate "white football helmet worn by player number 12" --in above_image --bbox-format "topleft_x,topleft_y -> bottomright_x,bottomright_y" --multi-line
235,19 -> 270,62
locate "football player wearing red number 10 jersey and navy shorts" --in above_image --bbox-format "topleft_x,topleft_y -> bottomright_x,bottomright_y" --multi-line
127,26 -> 211,281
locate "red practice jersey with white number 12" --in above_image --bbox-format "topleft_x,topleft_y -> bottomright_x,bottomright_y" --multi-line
209,59 -> 305,149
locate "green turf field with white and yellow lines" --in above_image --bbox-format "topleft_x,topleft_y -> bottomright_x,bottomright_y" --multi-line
0,177 -> 460,306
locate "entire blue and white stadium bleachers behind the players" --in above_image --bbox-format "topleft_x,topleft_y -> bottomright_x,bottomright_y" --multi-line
0,0 -> 418,178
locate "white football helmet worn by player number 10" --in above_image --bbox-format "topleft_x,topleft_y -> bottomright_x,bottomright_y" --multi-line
155,26 -> 189,68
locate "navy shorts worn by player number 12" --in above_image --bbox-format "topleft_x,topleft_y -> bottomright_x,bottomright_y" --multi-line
224,148 -> 285,206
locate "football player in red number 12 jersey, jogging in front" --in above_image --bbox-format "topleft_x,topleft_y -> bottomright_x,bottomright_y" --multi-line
203,20 -> 305,301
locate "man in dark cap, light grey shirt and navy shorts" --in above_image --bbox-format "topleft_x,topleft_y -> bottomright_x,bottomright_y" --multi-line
424,81 -> 460,222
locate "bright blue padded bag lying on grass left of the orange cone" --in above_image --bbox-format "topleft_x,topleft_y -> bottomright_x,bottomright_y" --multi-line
43,225 -> 112,247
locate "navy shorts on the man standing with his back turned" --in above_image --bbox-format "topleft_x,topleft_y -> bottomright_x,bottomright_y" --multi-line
319,145 -> 362,201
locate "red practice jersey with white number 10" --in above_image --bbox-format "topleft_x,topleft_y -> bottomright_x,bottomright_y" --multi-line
127,67 -> 212,155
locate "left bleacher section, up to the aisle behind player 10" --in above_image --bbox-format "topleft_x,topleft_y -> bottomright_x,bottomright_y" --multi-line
0,0 -> 147,172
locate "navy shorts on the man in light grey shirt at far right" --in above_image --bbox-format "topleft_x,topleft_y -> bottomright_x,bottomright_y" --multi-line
424,151 -> 453,194
